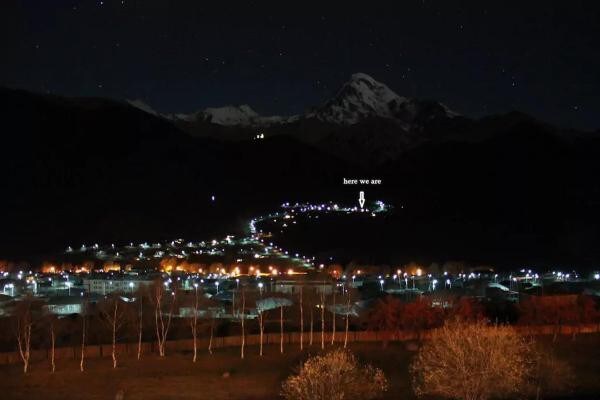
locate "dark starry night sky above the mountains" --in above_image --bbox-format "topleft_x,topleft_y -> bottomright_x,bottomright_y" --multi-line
0,0 -> 600,130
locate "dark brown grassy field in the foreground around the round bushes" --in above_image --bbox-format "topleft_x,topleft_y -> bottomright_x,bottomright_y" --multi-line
0,335 -> 600,400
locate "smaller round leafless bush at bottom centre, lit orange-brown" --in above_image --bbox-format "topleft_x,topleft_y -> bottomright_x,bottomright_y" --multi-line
281,349 -> 388,400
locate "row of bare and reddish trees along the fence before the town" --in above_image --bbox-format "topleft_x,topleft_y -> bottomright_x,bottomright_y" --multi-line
0,280 -> 600,373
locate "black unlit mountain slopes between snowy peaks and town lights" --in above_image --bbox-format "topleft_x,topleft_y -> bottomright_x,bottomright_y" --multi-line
0,89 -> 600,267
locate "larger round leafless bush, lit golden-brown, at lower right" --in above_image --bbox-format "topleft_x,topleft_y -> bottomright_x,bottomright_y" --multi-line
411,320 -> 534,400
